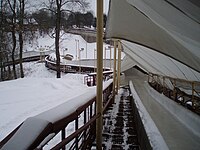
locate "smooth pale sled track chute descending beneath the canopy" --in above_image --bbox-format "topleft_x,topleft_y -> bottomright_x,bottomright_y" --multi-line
125,69 -> 200,150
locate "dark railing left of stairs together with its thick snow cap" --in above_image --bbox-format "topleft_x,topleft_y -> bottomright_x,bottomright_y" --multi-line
0,80 -> 113,150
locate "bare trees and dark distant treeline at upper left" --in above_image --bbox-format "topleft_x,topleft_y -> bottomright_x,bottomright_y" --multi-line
0,0 -> 106,81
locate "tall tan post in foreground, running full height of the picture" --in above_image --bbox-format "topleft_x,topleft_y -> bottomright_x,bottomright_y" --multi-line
96,0 -> 103,150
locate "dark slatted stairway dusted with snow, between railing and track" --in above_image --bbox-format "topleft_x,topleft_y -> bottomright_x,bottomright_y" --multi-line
102,87 -> 140,150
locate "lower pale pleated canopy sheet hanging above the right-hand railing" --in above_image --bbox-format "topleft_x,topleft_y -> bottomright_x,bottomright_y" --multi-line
122,40 -> 200,81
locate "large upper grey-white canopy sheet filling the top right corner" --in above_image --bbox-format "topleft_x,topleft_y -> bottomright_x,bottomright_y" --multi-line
106,0 -> 200,72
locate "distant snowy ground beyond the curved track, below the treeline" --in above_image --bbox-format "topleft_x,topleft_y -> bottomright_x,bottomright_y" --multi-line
24,32 -> 124,60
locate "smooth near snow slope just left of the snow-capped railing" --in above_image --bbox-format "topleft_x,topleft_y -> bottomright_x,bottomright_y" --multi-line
0,62 -> 88,140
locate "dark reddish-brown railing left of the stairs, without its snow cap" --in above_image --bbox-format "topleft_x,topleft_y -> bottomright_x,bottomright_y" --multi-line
0,83 -> 113,150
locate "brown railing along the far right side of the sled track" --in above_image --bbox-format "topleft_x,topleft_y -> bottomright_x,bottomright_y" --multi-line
148,73 -> 200,114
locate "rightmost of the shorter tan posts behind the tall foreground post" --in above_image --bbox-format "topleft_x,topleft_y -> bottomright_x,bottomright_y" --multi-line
117,41 -> 122,91
